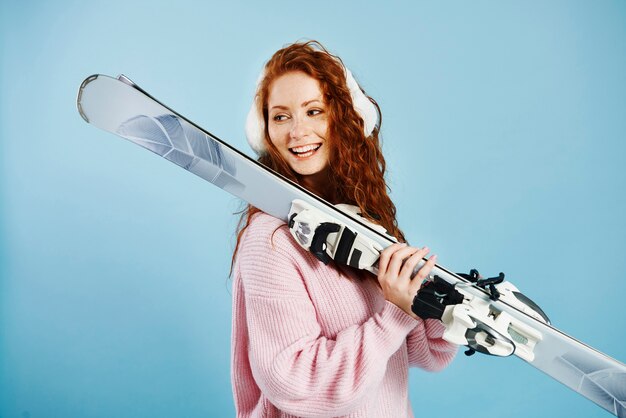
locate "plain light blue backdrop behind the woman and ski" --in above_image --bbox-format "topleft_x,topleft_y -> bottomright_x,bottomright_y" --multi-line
0,0 -> 626,418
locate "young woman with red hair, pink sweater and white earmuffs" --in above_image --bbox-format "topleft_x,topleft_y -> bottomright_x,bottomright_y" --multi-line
232,42 -> 457,418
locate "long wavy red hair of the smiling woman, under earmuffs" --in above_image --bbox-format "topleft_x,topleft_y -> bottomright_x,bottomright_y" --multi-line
231,41 -> 405,272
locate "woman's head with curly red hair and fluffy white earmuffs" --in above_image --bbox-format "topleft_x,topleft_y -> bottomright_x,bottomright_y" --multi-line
246,42 -> 394,229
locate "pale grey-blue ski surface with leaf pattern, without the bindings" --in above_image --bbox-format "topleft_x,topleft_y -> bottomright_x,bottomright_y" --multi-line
77,75 -> 626,418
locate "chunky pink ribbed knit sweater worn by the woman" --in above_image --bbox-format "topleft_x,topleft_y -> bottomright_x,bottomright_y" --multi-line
231,213 -> 457,418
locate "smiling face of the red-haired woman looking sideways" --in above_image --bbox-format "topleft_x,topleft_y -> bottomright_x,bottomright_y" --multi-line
267,71 -> 328,180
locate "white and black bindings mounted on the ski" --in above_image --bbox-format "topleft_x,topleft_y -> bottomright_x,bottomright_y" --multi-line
288,199 -> 550,362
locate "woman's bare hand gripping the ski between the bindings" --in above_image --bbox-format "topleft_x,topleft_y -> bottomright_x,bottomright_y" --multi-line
378,244 -> 437,318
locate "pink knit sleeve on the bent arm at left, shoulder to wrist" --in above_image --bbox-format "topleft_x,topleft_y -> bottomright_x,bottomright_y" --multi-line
238,214 -> 416,416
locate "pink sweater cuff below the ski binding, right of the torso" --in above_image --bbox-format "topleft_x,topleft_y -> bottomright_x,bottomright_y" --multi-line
407,319 -> 458,372
